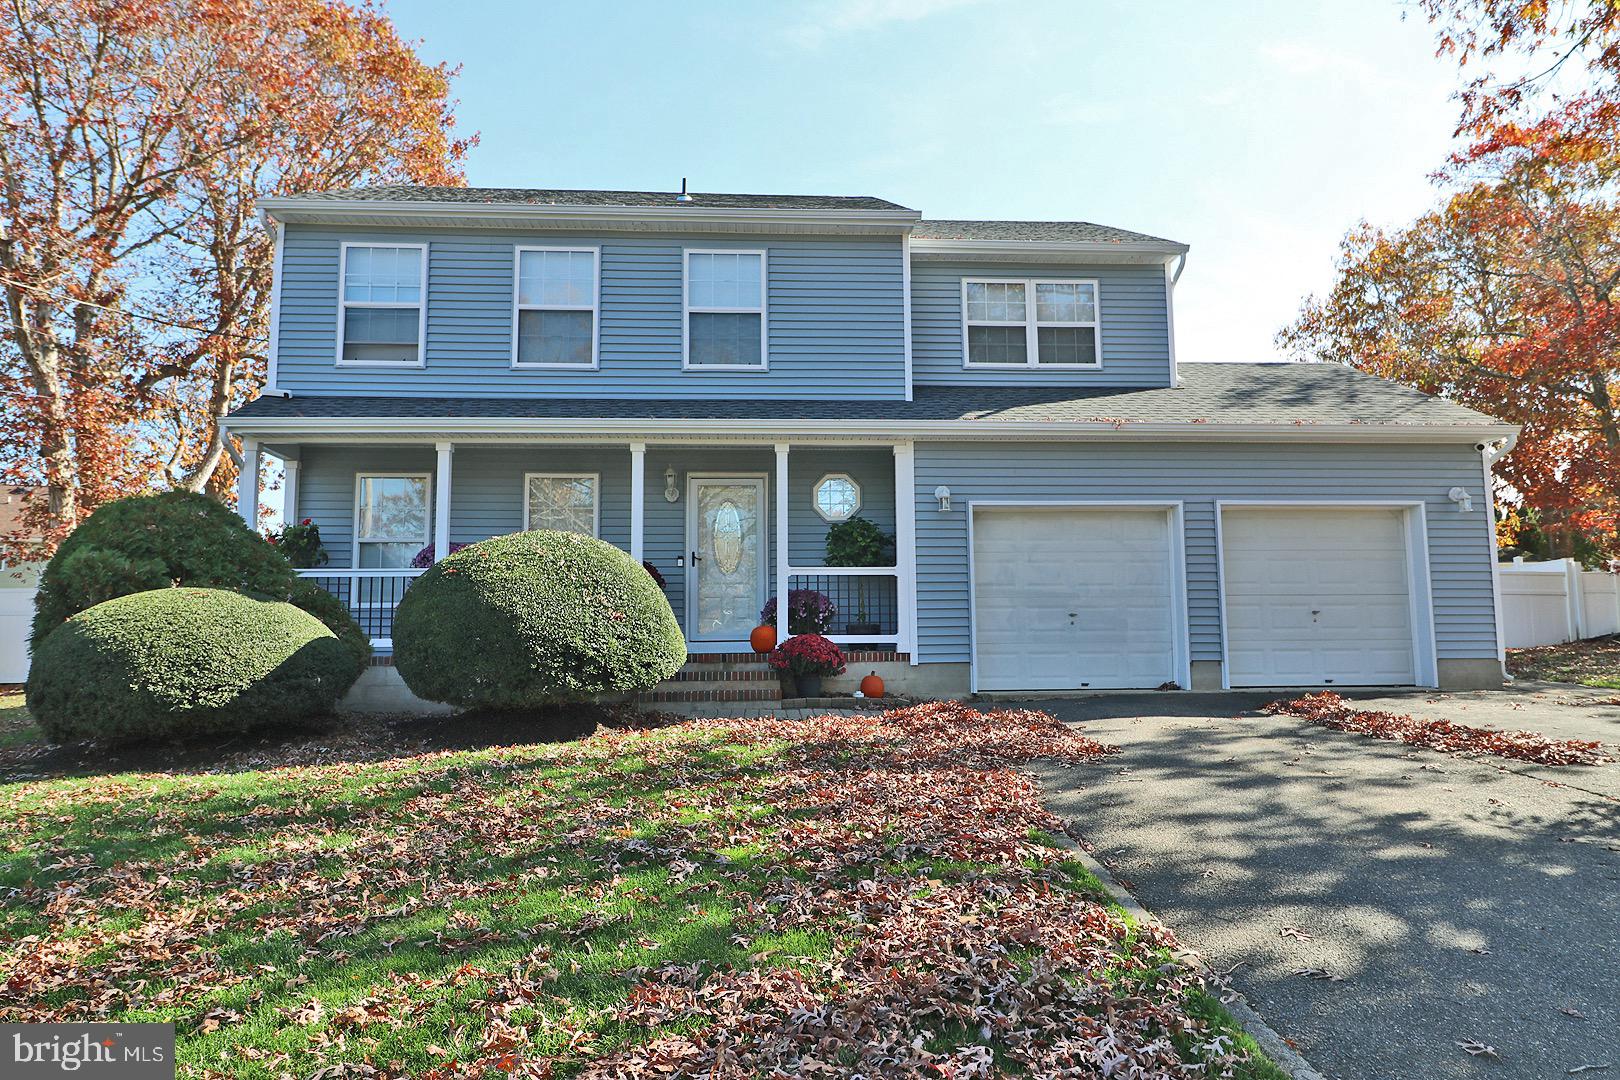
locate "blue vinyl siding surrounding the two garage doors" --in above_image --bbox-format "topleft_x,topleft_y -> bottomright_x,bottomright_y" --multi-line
915,442 -> 1497,662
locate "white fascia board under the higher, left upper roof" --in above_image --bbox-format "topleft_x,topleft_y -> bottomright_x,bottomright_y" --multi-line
259,196 -> 922,232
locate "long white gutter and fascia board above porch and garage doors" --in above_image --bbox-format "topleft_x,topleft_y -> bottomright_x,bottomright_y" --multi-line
224,416 -> 1518,444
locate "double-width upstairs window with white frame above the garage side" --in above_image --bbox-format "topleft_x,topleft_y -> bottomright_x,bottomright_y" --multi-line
962,279 -> 1103,368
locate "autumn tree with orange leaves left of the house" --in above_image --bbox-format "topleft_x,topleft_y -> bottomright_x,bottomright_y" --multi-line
0,0 -> 470,553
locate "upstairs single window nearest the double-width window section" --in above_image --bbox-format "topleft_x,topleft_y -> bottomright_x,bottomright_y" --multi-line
684,251 -> 766,371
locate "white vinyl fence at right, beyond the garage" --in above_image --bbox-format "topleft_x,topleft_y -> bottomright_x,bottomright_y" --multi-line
1500,559 -> 1620,649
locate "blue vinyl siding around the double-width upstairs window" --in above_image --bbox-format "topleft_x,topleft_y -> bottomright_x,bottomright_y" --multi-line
912,259 -> 1170,387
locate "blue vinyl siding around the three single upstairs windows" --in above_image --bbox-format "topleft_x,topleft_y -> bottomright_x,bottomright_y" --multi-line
277,225 -> 906,398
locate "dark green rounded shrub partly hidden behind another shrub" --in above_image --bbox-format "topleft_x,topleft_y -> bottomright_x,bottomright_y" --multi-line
31,491 -> 371,682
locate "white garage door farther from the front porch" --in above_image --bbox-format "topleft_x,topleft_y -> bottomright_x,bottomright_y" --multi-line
1221,507 -> 1418,687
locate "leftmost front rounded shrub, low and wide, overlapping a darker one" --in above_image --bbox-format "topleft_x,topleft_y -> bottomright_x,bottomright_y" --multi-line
28,588 -> 355,742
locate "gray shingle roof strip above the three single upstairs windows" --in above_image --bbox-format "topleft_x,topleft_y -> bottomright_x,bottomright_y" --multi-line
300,185 -> 909,210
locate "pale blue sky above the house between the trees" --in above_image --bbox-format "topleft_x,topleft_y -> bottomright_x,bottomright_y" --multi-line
387,0 -> 1458,359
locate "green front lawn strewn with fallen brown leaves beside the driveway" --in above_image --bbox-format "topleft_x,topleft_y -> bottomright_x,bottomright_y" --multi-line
0,703 -> 1283,1080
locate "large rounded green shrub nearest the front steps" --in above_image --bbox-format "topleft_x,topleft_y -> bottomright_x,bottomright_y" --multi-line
394,531 -> 687,709
